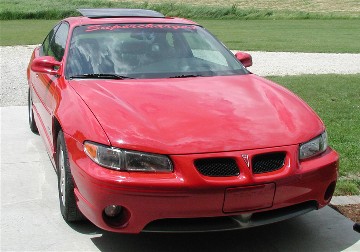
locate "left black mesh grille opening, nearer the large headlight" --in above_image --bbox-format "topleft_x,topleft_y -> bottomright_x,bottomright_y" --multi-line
194,158 -> 240,177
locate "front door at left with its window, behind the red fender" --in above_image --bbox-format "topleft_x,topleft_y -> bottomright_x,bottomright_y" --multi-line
33,22 -> 69,156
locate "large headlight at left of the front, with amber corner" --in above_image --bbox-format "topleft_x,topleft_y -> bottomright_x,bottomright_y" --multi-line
84,142 -> 173,172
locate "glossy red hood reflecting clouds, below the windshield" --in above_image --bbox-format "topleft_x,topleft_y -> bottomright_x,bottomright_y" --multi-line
70,74 -> 324,154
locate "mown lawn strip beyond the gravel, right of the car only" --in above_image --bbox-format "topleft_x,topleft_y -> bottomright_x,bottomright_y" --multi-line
198,20 -> 360,53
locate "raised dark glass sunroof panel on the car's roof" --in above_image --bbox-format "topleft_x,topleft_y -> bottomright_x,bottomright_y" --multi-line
77,9 -> 165,18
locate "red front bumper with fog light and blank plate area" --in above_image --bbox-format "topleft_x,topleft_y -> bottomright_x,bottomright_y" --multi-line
66,136 -> 339,233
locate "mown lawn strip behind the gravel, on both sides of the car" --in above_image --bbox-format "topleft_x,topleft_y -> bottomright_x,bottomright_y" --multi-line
0,20 -> 360,53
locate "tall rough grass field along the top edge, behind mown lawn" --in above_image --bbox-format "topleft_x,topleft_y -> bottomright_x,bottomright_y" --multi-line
0,0 -> 360,20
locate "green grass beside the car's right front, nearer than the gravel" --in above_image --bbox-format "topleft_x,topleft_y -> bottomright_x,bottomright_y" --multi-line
270,74 -> 360,195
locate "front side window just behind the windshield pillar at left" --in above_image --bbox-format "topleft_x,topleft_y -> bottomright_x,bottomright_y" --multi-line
48,23 -> 69,61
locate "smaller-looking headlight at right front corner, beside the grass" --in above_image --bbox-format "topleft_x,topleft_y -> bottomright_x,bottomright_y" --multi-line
299,131 -> 328,160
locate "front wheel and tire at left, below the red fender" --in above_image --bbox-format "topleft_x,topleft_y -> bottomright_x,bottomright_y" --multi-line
56,130 -> 84,222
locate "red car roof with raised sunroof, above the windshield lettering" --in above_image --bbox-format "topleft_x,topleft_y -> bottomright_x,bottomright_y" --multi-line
64,8 -> 197,26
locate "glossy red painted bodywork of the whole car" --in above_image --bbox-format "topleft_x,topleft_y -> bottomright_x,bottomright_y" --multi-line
28,14 -> 339,233
